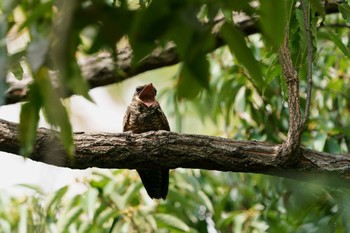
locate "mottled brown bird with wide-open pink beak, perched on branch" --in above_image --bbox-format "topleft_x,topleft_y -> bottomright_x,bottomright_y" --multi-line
123,83 -> 170,199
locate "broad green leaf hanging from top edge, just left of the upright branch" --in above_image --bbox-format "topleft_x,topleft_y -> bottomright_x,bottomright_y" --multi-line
260,0 -> 286,49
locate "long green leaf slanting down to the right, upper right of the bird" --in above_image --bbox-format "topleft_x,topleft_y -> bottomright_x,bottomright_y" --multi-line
221,23 -> 264,88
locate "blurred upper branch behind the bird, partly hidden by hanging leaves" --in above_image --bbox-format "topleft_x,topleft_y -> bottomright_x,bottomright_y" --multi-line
5,1 -> 342,104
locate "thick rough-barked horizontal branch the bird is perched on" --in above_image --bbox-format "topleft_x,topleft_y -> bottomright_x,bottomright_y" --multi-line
0,120 -> 350,188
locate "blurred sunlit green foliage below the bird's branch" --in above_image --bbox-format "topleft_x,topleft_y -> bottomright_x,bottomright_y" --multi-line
0,169 -> 350,233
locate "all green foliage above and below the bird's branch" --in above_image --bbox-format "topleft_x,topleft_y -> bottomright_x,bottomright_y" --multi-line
0,0 -> 350,232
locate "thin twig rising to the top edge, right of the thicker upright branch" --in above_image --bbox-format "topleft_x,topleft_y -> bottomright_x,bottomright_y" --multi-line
301,0 -> 313,129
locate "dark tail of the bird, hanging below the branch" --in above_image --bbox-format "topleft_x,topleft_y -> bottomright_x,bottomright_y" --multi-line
137,169 -> 169,200
